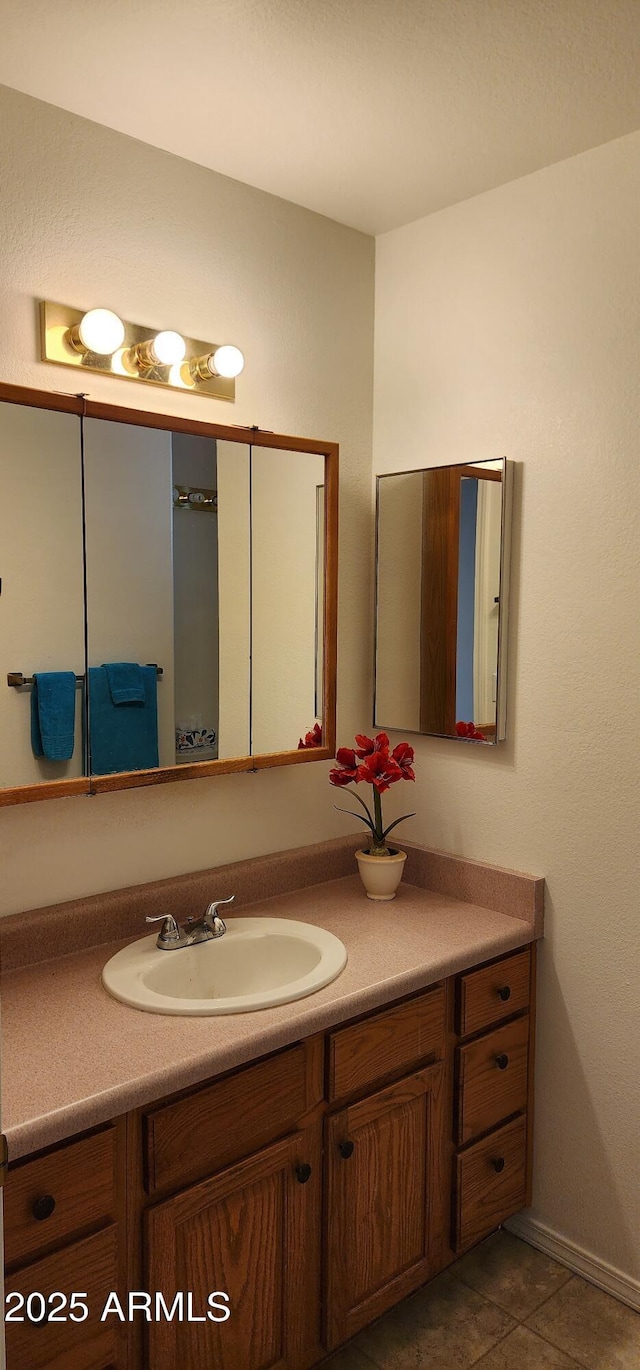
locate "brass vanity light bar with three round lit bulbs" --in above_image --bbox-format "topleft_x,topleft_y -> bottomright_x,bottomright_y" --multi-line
40,300 -> 244,401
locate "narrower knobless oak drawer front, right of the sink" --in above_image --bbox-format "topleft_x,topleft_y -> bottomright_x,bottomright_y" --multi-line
329,985 -> 444,1100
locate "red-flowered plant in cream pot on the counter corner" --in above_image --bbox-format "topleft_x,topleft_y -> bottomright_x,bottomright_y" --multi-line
329,733 -> 415,899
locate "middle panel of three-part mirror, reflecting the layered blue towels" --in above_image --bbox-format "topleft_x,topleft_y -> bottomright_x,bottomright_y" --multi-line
80,419 -> 249,775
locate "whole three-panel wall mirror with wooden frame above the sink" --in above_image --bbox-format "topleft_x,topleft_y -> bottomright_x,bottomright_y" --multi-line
0,386 -> 337,804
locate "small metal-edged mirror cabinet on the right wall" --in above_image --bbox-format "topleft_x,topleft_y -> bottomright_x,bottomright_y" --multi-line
374,459 -> 511,744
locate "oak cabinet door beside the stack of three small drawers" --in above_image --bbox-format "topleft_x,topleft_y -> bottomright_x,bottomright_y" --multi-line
325,1064 -> 448,1348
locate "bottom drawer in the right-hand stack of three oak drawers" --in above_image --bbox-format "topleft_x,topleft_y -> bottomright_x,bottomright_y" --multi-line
454,1117 -> 526,1251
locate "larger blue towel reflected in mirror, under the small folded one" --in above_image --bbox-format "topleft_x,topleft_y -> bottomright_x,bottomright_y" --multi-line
89,666 -> 159,775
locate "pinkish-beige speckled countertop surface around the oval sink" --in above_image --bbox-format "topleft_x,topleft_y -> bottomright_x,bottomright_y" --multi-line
1,875 -> 536,1160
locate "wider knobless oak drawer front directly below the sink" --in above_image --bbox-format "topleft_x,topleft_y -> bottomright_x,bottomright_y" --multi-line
145,1038 -> 317,1193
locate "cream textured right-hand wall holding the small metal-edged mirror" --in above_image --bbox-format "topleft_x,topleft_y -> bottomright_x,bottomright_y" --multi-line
374,134 -> 640,1280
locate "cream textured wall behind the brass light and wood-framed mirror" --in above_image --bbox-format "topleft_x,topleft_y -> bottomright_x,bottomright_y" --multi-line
0,89 -> 374,912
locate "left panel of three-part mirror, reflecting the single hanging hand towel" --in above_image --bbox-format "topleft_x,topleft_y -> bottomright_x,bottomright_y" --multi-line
0,404 -> 85,788
